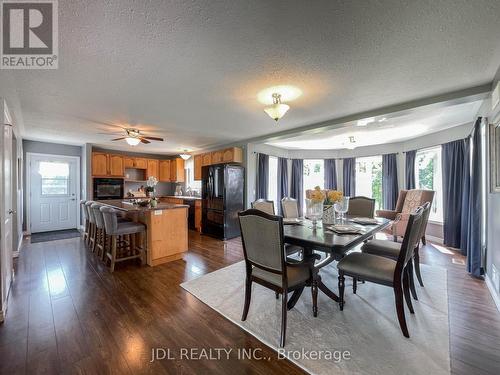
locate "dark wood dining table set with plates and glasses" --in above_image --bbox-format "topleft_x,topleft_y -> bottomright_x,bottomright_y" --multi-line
284,218 -> 391,316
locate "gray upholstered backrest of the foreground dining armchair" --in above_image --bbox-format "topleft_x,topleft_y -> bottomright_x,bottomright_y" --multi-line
238,209 -> 286,273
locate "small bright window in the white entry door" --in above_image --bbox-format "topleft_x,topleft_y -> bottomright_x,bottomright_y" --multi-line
38,161 -> 69,195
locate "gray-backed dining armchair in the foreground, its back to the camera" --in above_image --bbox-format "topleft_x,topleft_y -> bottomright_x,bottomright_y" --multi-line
238,209 -> 318,347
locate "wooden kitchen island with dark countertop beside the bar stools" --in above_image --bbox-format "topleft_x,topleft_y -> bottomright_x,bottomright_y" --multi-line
99,200 -> 189,266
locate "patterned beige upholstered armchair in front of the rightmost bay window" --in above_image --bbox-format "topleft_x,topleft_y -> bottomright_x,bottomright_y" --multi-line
376,189 -> 435,245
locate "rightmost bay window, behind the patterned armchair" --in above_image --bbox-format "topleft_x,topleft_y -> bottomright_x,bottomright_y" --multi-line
415,147 -> 443,223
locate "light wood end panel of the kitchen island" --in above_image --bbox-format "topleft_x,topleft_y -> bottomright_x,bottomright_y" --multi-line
141,207 -> 188,266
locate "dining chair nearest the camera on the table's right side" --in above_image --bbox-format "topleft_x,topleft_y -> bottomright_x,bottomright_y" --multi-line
337,207 -> 424,337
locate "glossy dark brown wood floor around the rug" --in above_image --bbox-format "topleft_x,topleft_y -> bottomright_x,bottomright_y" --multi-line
0,232 -> 500,374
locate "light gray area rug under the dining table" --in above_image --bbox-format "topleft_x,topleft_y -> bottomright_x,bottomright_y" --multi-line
181,262 -> 450,375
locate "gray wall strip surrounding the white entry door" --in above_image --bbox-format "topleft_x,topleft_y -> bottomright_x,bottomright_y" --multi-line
23,139 -> 86,230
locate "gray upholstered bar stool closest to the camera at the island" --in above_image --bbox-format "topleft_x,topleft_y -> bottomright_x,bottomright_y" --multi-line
100,206 -> 147,272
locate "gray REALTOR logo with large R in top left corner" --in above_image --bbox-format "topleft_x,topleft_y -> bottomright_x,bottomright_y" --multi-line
0,0 -> 58,69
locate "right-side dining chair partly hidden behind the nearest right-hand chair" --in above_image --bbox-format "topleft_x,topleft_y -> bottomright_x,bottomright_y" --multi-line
361,202 -> 431,290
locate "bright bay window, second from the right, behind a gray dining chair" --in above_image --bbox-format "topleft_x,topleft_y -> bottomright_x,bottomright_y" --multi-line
356,156 -> 382,210
